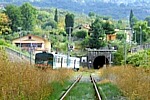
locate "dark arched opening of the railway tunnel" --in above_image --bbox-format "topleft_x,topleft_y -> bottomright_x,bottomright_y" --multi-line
93,56 -> 109,69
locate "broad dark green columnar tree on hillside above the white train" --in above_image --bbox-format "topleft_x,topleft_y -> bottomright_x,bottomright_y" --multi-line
65,13 -> 74,34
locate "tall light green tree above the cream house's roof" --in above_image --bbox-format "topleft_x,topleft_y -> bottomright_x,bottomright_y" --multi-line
20,3 -> 37,31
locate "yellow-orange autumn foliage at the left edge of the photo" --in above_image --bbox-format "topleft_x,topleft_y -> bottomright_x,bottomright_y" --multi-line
0,13 -> 11,35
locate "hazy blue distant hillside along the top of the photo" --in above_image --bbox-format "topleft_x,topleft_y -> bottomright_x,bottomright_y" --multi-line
0,0 -> 150,19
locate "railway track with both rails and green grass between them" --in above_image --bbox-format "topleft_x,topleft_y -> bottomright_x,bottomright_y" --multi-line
60,74 -> 102,100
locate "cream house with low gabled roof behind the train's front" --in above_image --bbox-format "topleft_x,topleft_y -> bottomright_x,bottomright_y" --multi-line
12,34 -> 51,54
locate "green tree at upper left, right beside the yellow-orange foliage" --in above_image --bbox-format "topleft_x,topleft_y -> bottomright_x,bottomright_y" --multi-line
5,5 -> 22,32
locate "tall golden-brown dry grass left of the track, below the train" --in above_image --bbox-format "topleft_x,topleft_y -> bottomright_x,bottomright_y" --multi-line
0,50 -> 72,100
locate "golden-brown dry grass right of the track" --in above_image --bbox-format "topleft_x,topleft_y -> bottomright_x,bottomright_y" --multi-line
101,66 -> 150,100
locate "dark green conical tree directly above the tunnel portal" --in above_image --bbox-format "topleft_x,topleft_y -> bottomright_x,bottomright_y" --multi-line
88,19 -> 105,49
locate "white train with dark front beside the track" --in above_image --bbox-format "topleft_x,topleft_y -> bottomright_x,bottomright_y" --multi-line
35,52 -> 80,71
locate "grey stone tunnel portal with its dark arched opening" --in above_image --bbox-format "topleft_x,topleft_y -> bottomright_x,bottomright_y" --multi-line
87,48 -> 116,69
